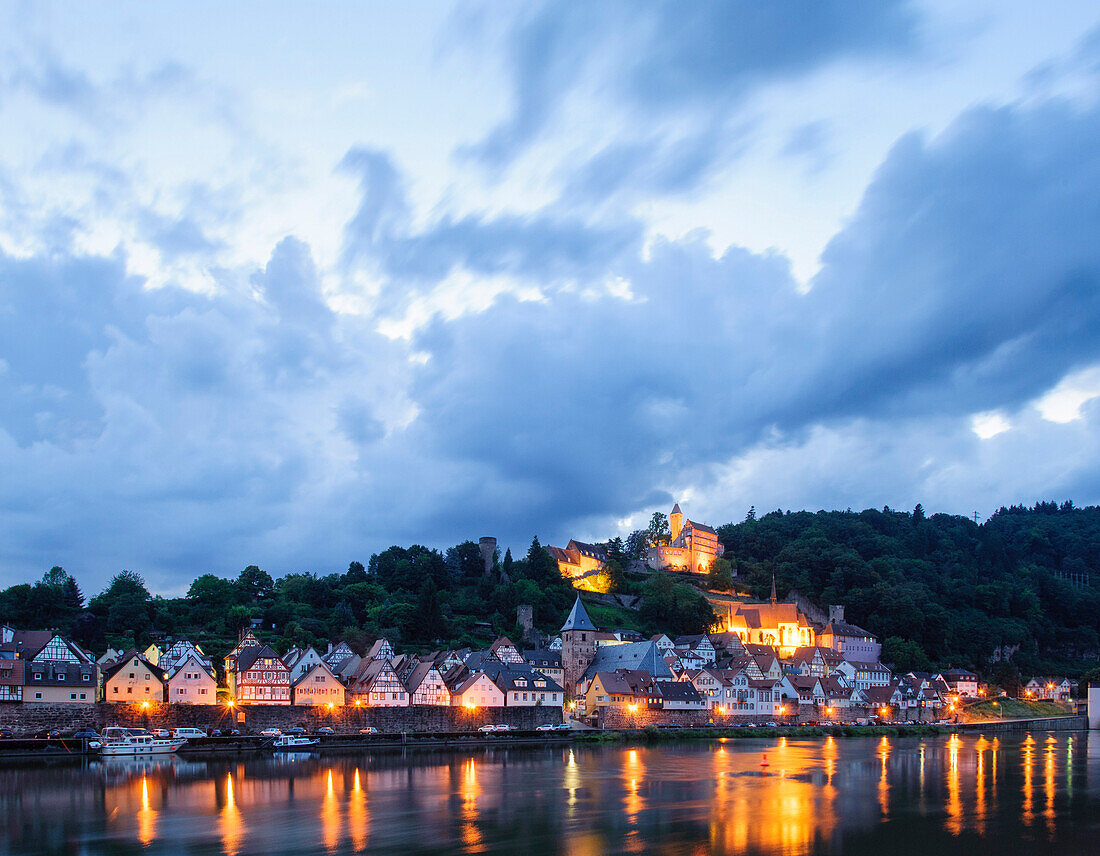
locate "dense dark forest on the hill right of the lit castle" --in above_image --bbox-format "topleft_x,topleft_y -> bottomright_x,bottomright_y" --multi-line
718,503 -> 1100,683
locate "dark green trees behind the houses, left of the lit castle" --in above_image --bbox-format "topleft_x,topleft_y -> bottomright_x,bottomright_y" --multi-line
0,538 -> 594,658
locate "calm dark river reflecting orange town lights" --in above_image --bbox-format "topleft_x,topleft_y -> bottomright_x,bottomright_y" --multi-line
0,732 -> 1100,856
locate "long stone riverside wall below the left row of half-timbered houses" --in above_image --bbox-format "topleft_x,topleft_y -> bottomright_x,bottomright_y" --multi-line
0,702 -> 562,736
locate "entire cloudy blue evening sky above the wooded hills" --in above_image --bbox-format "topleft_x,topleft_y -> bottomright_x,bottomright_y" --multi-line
0,0 -> 1100,593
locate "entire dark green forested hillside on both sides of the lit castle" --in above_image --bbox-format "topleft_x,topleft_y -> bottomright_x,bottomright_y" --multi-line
0,503 -> 1100,684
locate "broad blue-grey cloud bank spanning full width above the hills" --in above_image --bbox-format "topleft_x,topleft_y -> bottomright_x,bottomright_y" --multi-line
0,63 -> 1100,590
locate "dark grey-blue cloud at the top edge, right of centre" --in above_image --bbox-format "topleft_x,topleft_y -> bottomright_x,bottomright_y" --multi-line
466,0 -> 920,193
